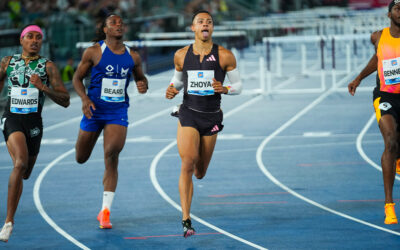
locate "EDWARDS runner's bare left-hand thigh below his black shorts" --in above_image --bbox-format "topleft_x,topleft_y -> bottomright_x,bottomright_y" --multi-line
7,131 -> 29,164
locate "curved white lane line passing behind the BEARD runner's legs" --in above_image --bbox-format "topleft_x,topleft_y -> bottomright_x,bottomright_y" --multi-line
33,107 -> 172,250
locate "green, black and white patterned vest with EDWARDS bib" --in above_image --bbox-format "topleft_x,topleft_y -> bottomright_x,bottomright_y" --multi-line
4,54 -> 49,116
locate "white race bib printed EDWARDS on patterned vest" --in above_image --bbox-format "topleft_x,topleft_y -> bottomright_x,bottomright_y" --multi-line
10,87 -> 39,114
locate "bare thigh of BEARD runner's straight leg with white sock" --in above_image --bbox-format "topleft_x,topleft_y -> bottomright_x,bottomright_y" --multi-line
104,124 -> 127,152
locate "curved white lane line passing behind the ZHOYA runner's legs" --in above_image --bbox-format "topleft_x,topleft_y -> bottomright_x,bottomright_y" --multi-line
150,96 -> 266,249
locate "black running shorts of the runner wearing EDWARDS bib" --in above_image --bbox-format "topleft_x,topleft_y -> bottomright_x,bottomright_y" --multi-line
0,115 -> 43,156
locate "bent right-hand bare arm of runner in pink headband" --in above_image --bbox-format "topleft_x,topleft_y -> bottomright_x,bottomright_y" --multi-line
30,61 -> 69,108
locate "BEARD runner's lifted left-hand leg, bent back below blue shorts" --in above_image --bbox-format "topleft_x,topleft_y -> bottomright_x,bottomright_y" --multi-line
75,129 -> 101,164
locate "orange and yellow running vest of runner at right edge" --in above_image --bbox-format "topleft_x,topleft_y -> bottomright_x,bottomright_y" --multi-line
376,28 -> 400,94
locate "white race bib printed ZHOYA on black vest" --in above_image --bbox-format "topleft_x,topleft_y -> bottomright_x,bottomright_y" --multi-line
187,70 -> 214,96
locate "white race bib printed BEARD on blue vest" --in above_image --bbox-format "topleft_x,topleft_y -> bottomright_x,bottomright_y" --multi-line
100,78 -> 126,102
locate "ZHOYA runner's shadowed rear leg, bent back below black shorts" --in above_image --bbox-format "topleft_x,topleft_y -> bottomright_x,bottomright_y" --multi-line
194,134 -> 218,179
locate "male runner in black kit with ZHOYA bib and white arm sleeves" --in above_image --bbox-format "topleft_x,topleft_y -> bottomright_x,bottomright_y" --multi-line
166,11 -> 242,238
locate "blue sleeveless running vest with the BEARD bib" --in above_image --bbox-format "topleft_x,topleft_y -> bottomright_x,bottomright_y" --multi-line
88,41 -> 135,113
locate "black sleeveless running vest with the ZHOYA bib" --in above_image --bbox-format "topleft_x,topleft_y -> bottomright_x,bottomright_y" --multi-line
183,44 -> 226,112
